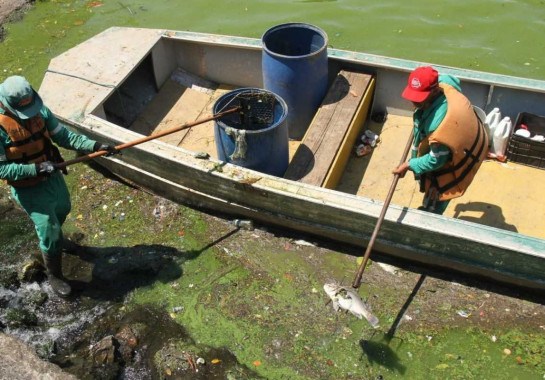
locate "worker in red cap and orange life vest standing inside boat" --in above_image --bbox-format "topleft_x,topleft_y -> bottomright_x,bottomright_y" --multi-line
393,66 -> 488,214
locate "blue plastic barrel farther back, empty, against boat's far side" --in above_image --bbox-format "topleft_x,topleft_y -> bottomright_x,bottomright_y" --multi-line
262,23 -> 328,140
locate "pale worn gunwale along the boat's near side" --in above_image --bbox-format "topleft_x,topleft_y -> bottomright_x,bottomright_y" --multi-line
59,110 -> 545,258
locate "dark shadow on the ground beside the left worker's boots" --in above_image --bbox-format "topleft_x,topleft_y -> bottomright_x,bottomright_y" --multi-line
63,244 -> 184,301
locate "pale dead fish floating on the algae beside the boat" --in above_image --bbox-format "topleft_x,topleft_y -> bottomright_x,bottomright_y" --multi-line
324,282 -> 379,329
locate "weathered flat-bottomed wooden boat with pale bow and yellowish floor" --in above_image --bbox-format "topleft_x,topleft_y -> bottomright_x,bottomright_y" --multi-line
39,27 -> 545,291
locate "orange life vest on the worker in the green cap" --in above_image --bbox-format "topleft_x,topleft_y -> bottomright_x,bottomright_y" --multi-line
0,110 -> 51,187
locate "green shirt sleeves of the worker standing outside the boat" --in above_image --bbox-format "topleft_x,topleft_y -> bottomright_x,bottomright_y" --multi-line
0,105 -> 95,181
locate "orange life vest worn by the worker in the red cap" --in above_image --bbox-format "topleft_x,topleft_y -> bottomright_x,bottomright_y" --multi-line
418,83 -> 488,201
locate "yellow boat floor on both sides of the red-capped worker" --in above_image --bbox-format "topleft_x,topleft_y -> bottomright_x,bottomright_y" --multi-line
337,115 -> 545,238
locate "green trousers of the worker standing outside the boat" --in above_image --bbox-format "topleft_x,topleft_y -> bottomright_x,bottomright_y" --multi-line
11,171 -> 71,256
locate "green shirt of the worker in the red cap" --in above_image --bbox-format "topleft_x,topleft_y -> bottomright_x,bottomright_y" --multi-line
409,75 -> 461,177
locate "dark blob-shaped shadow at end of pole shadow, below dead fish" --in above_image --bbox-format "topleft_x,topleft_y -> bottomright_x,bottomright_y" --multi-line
359,334 -> 407,375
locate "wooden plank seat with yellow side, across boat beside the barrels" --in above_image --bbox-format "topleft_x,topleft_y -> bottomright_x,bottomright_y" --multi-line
284,70 -> 375,189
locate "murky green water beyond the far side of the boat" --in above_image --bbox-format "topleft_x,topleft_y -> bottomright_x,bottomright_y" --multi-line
0,0 -> 545,83
